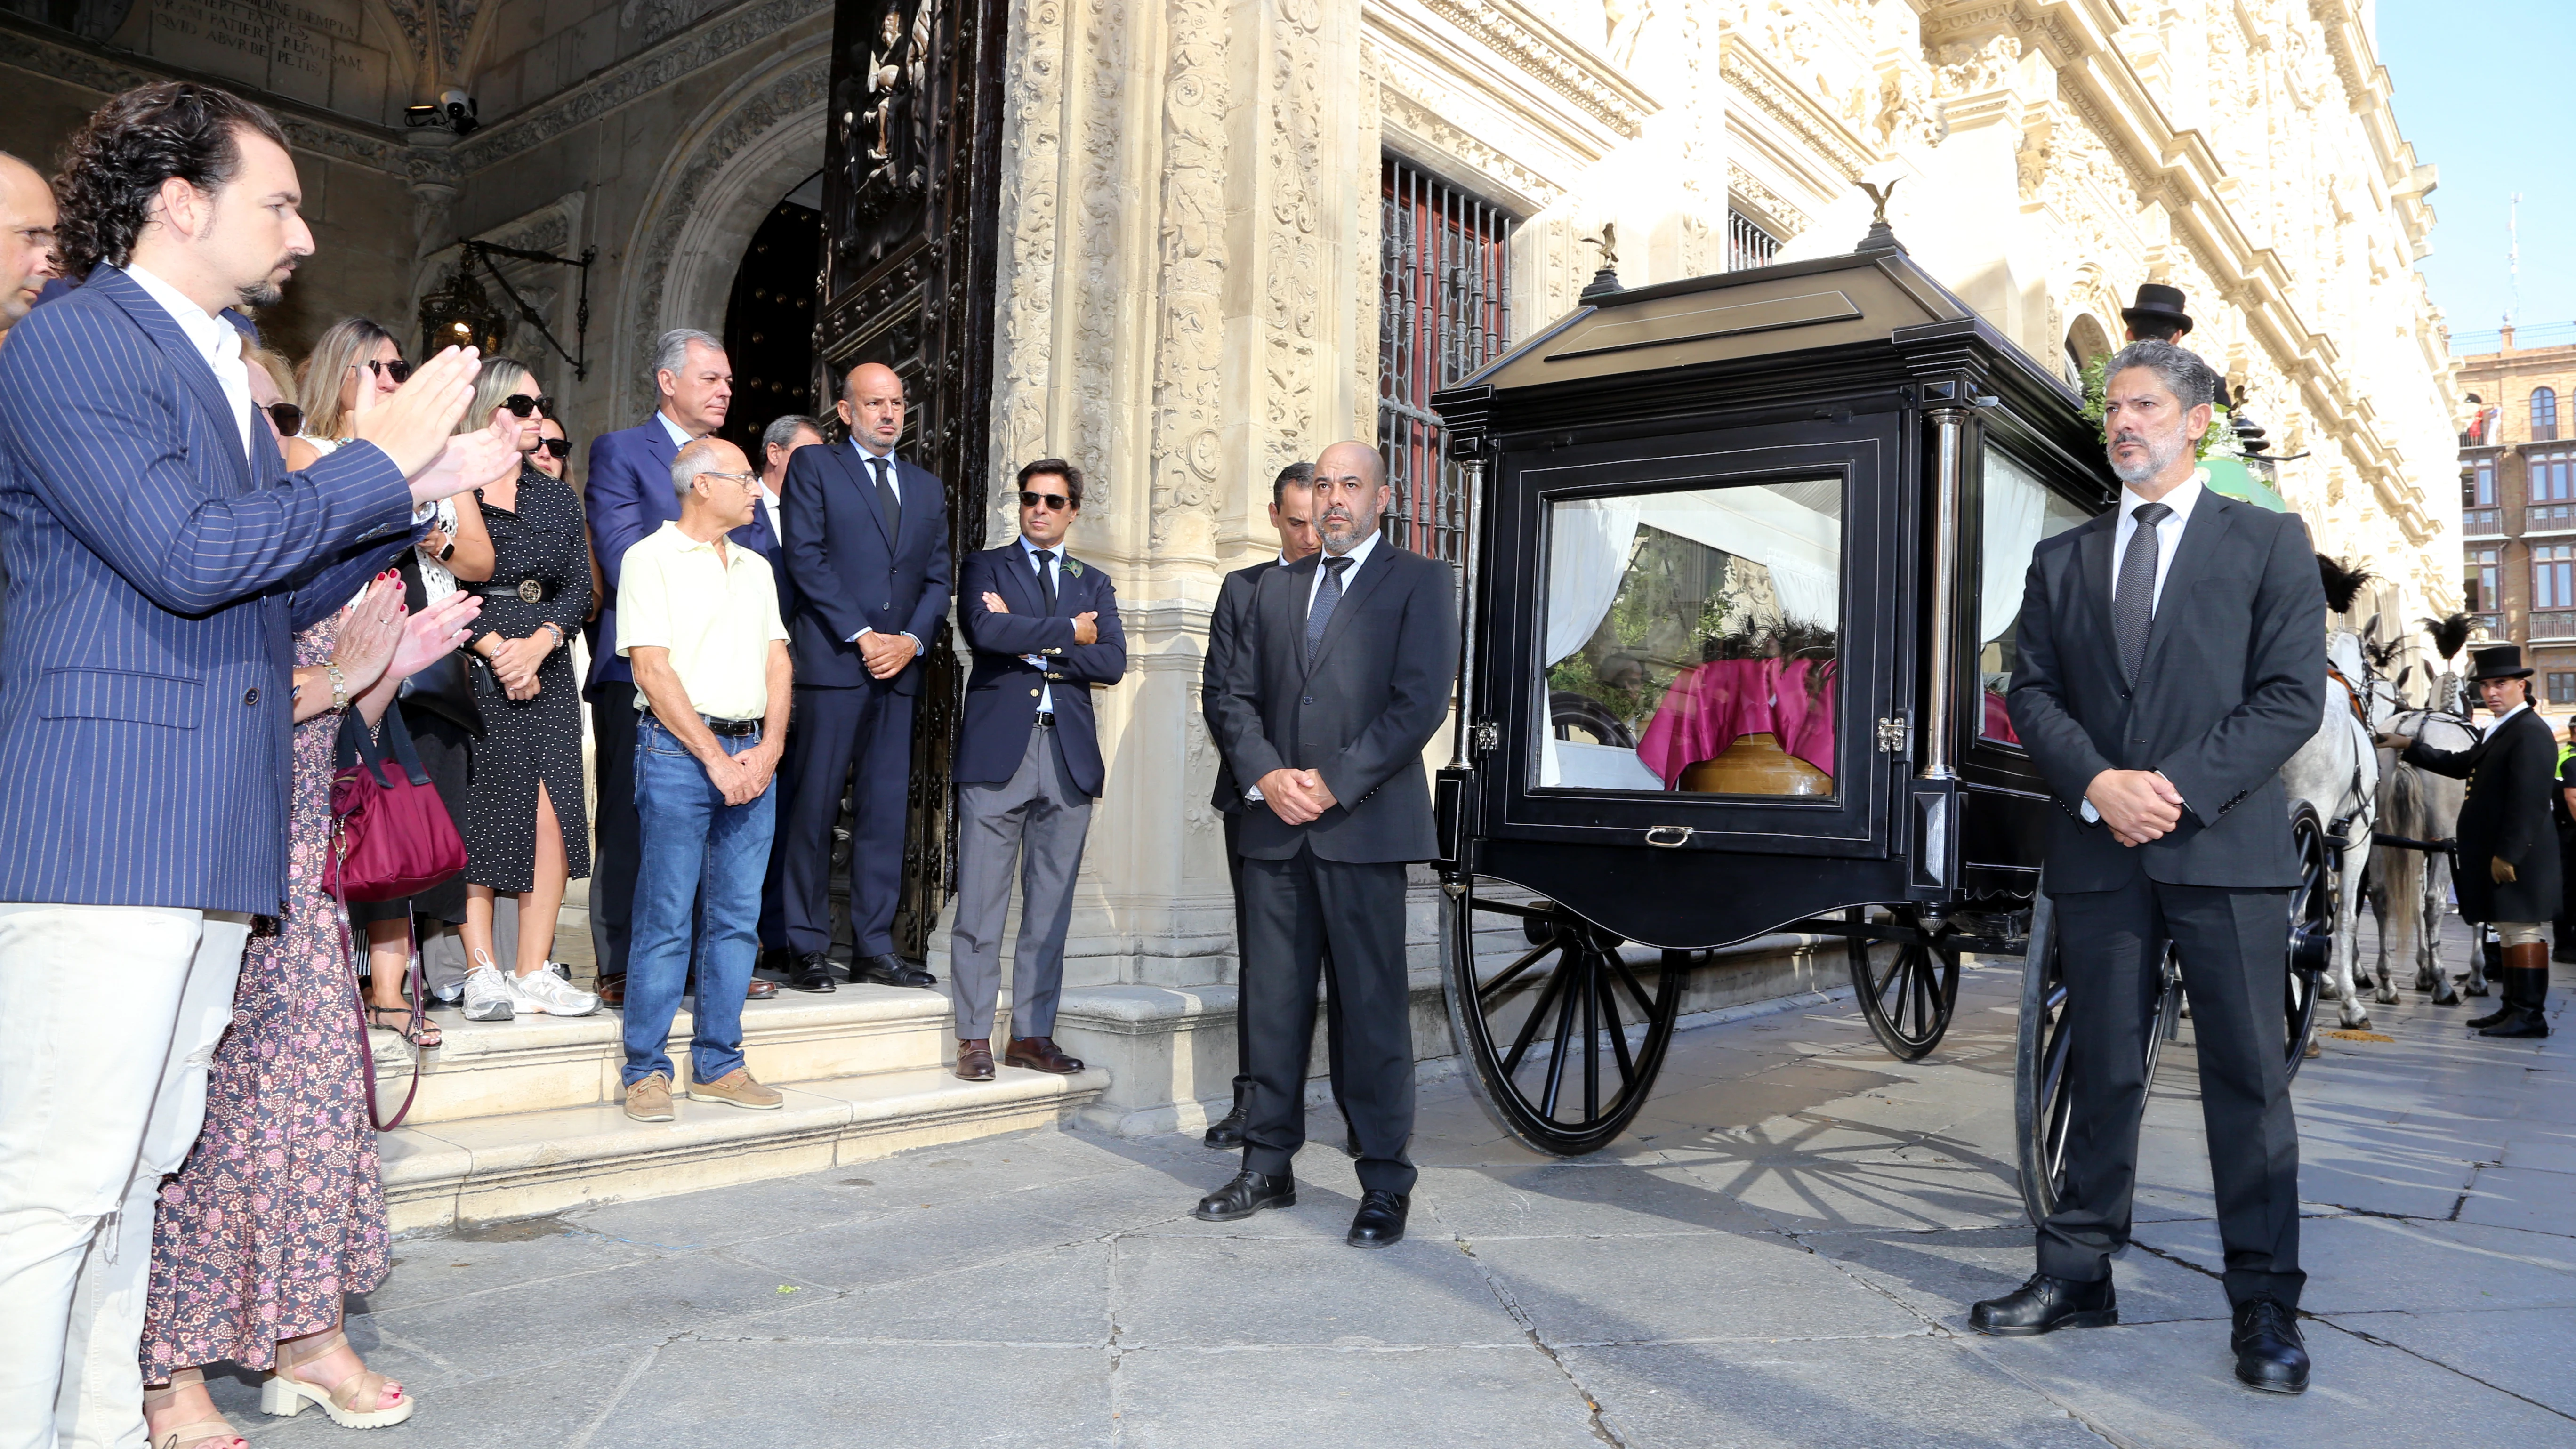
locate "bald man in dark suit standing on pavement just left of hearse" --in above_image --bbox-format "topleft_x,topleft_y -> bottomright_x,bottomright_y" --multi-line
1198,443 -> 1458,1248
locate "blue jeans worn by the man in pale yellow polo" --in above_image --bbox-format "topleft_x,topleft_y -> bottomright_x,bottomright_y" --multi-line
626,717 -> 778,1086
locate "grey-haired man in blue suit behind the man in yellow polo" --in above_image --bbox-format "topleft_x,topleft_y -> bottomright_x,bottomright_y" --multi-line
582,328 -> 778,1006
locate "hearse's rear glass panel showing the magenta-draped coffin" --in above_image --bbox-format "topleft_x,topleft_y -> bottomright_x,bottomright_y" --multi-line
1530,475 -> 1844,802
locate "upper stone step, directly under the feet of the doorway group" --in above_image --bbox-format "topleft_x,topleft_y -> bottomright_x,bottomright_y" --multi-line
371,982 -> 1007,1127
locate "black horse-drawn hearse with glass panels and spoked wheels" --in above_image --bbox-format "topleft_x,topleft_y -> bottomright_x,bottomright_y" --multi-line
1432,224 -> 2324,1212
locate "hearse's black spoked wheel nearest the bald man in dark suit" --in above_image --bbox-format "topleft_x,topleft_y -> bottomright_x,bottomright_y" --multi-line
1440,877 -> 1692,1158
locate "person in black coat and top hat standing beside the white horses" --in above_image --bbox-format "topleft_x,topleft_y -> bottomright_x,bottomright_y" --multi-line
2380,644 -> 2566,1037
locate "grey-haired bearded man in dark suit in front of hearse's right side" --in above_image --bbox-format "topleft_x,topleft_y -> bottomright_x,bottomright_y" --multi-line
1968,340 -> 2326,1393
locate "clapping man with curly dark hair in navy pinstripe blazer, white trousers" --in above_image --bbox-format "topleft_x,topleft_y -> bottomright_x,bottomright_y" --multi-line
0,82 -> 507,1449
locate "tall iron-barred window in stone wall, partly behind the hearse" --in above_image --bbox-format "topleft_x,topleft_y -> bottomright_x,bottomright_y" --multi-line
1378,157 -> 1512,562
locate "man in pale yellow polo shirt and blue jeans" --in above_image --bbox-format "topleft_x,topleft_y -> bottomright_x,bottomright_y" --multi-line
618,438 -> 791,1121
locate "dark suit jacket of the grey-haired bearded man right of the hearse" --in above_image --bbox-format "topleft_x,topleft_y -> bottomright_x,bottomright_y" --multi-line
2007,490 -> 2326,894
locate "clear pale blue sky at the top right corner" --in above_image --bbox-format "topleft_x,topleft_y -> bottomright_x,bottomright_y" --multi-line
2378,0 -> 2576,351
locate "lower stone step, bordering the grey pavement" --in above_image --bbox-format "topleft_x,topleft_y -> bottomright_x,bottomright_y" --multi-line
376,1057 -> 1108,1232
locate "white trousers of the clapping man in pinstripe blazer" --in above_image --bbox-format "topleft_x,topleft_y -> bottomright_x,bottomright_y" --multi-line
0,905 -> 250,1449
